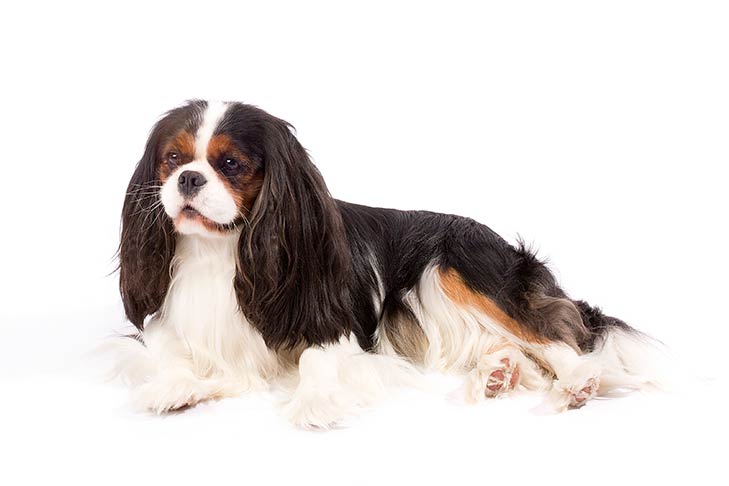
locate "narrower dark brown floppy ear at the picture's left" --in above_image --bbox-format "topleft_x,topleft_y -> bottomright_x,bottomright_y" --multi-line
118,120 -> 175,330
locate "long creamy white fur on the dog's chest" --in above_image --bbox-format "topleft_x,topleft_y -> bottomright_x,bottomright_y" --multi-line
144,233 -> 277,390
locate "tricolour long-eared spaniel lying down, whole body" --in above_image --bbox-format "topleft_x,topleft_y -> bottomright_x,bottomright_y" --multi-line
116,100 -> 652,427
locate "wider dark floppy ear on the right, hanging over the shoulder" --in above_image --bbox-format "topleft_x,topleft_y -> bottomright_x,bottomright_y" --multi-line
235,115 -> 355,349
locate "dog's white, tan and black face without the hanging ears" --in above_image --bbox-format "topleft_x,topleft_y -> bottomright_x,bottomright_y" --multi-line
155,103 -> 264,236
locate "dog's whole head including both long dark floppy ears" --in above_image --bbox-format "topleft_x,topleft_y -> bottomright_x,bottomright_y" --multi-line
119,101 -> 348,345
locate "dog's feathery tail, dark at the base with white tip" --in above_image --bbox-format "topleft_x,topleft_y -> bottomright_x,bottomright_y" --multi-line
574,301 -> 675,395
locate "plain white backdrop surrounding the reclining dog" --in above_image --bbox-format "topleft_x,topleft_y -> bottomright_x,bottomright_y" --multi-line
0,0 -> 729,484
